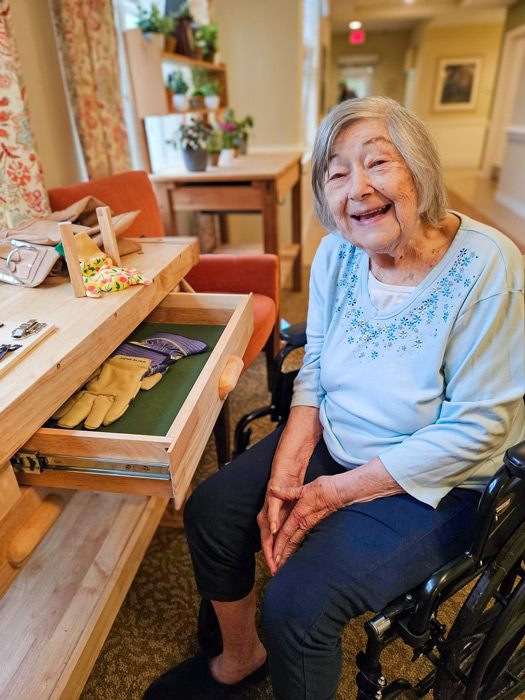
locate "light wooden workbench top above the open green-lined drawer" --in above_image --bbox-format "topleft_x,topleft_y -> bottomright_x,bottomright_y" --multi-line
0,239 -> 198,465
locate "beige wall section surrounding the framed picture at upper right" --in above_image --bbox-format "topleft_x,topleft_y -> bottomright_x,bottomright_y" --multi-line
412,21 -> 503,167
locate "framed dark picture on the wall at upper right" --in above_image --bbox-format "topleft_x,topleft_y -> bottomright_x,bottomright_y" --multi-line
434,58 -> 481,112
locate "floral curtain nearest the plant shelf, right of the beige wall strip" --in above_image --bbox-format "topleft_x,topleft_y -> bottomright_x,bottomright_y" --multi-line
50,0 -> 131,179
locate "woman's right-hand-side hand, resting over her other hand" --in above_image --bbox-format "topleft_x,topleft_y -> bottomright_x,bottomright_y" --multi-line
265,476 -> 344,574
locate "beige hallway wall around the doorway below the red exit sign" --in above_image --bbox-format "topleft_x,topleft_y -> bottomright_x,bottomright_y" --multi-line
330,31 -> 410,104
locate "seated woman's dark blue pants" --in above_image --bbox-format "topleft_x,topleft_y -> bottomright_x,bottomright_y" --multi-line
185,430 -> 479,700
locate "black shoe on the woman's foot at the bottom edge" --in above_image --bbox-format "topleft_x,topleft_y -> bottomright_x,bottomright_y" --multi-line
143,652 -> 268,700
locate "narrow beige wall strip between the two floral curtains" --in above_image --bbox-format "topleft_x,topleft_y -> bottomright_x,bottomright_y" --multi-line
11,0 -> 85,189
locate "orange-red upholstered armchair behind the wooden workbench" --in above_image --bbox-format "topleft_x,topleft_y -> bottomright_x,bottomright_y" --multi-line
48,171 -> 279,462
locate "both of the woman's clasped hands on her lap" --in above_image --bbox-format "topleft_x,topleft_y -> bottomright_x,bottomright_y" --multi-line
257,475 -> 345,575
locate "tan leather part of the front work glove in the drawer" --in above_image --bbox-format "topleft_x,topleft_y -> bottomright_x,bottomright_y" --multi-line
53,355 -> 151,430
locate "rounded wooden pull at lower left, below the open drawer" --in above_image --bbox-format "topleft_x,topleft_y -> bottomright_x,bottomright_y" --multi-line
7,494 -> 65,569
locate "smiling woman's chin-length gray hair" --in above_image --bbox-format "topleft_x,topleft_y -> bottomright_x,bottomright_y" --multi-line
312,97 -> 448,231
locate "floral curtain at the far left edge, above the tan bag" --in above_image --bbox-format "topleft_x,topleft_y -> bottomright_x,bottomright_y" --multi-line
0,0 -> 49,229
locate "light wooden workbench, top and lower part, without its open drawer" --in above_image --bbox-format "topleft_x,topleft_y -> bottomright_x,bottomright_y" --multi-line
0,242 -> 239,700
